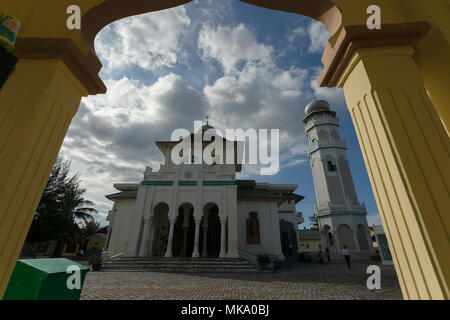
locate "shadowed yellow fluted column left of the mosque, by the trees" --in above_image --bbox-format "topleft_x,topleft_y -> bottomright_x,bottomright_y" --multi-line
0,60 -> 87,297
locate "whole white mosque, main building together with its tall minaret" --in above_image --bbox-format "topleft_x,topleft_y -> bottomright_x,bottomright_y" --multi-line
105,100 -> 373,263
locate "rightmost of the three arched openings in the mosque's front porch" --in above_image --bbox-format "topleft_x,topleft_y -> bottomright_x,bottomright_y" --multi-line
199,203 -> 221,258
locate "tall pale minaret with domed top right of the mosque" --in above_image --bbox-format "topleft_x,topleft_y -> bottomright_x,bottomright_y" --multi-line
303,100 -> 373,252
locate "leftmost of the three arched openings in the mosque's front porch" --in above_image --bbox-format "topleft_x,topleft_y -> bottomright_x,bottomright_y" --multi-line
151,202 -> 170,257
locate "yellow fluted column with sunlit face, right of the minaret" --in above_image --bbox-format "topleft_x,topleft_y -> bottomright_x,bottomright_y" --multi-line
338,46 -> 450,299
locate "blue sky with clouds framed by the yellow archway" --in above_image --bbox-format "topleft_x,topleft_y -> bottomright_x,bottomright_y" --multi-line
62,0 -> 380,228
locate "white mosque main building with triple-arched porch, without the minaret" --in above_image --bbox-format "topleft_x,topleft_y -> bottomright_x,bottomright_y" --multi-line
105,123 -> 303,262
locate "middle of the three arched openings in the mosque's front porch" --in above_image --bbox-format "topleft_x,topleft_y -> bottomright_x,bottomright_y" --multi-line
172,203 -> 195,257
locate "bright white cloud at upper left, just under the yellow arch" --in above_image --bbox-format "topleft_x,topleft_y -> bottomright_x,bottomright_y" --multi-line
95,7 -> 191,70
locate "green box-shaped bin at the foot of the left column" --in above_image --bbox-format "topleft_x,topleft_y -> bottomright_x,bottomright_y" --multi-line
3,258 -> 89,300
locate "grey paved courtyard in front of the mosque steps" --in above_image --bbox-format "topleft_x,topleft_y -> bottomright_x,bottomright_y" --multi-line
81,262 -> 402,300
